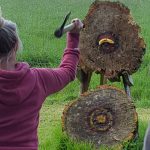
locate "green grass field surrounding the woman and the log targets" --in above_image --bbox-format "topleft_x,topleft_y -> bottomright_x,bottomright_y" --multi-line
0,0 -> 150,150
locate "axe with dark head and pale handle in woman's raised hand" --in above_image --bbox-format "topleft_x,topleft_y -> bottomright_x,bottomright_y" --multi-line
54,12 -> 75,38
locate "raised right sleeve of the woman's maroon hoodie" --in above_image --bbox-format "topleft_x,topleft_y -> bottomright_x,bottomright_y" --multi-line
33,33 -> 79,96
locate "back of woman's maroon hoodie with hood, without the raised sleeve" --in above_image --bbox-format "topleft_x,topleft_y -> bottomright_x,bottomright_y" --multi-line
0,63 -> 46,150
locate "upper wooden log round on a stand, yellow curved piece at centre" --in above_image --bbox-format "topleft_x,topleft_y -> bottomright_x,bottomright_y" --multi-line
80,0 -> 146,79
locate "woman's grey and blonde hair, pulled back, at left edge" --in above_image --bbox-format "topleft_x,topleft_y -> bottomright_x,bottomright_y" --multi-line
0,11 -> 22,58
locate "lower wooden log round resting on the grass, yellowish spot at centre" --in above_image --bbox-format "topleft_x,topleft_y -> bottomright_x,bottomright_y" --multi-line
62,86 -> 138,147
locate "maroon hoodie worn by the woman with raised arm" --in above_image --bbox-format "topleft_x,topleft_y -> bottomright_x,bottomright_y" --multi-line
0,33 -> 79,150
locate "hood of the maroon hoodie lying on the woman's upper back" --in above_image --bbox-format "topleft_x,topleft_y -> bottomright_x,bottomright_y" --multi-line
0,63 -> 35,105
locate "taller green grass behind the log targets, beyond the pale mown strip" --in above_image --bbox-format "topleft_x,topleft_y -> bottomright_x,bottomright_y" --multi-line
0,0 -> 150,107
